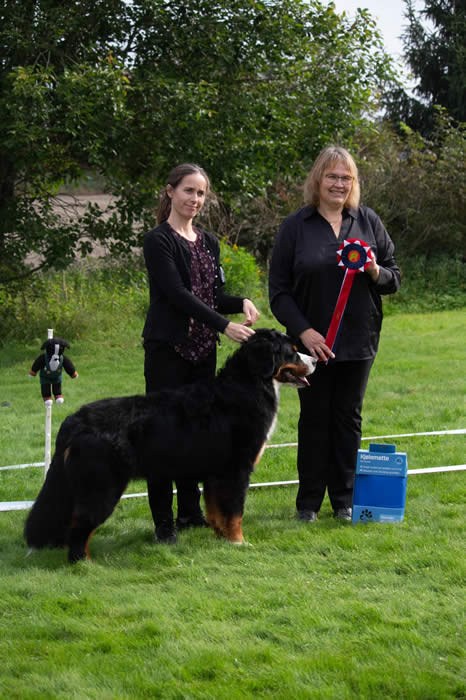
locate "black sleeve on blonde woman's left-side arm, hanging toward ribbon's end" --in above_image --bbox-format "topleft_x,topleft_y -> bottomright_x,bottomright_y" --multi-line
269,216 -> 310,338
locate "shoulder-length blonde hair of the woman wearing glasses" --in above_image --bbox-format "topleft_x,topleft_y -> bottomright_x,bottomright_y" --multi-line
304,146 -> 361,209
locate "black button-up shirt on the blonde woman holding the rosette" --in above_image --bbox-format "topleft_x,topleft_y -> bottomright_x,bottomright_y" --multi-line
269,206 -> 400,361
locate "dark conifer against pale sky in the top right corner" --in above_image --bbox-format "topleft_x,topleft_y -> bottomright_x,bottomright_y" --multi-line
386,0 -> 466,135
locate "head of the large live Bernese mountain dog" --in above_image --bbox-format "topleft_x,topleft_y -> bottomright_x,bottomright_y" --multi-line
243,328 -> 316,389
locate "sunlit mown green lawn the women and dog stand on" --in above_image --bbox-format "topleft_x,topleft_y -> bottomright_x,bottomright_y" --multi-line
0,311 -> 466,700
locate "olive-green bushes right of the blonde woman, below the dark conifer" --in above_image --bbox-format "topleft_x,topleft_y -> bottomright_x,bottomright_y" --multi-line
356,110 -> 466,258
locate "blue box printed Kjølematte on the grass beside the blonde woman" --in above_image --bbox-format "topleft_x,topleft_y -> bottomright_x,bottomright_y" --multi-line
352,443 -> 408,524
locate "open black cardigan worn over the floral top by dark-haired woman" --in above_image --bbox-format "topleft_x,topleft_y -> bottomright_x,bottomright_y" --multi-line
142,221 -> 244,344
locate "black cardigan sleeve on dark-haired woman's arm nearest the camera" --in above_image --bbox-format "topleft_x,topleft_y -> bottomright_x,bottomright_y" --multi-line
144,227 -> 229,333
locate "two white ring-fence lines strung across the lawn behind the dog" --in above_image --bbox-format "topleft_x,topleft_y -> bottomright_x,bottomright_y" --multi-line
0,428 -> 466,512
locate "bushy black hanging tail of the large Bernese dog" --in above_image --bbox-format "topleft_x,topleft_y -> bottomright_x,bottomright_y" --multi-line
24,451 -> 73,549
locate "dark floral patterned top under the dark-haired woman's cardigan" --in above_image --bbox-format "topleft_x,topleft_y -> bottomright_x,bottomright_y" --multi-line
172,229 -> 217,364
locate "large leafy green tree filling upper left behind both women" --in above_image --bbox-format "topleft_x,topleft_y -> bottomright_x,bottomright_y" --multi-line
0,0 -> 391,282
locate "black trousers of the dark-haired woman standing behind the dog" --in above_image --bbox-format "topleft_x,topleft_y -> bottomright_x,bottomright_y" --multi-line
144,341 -> 217,527
